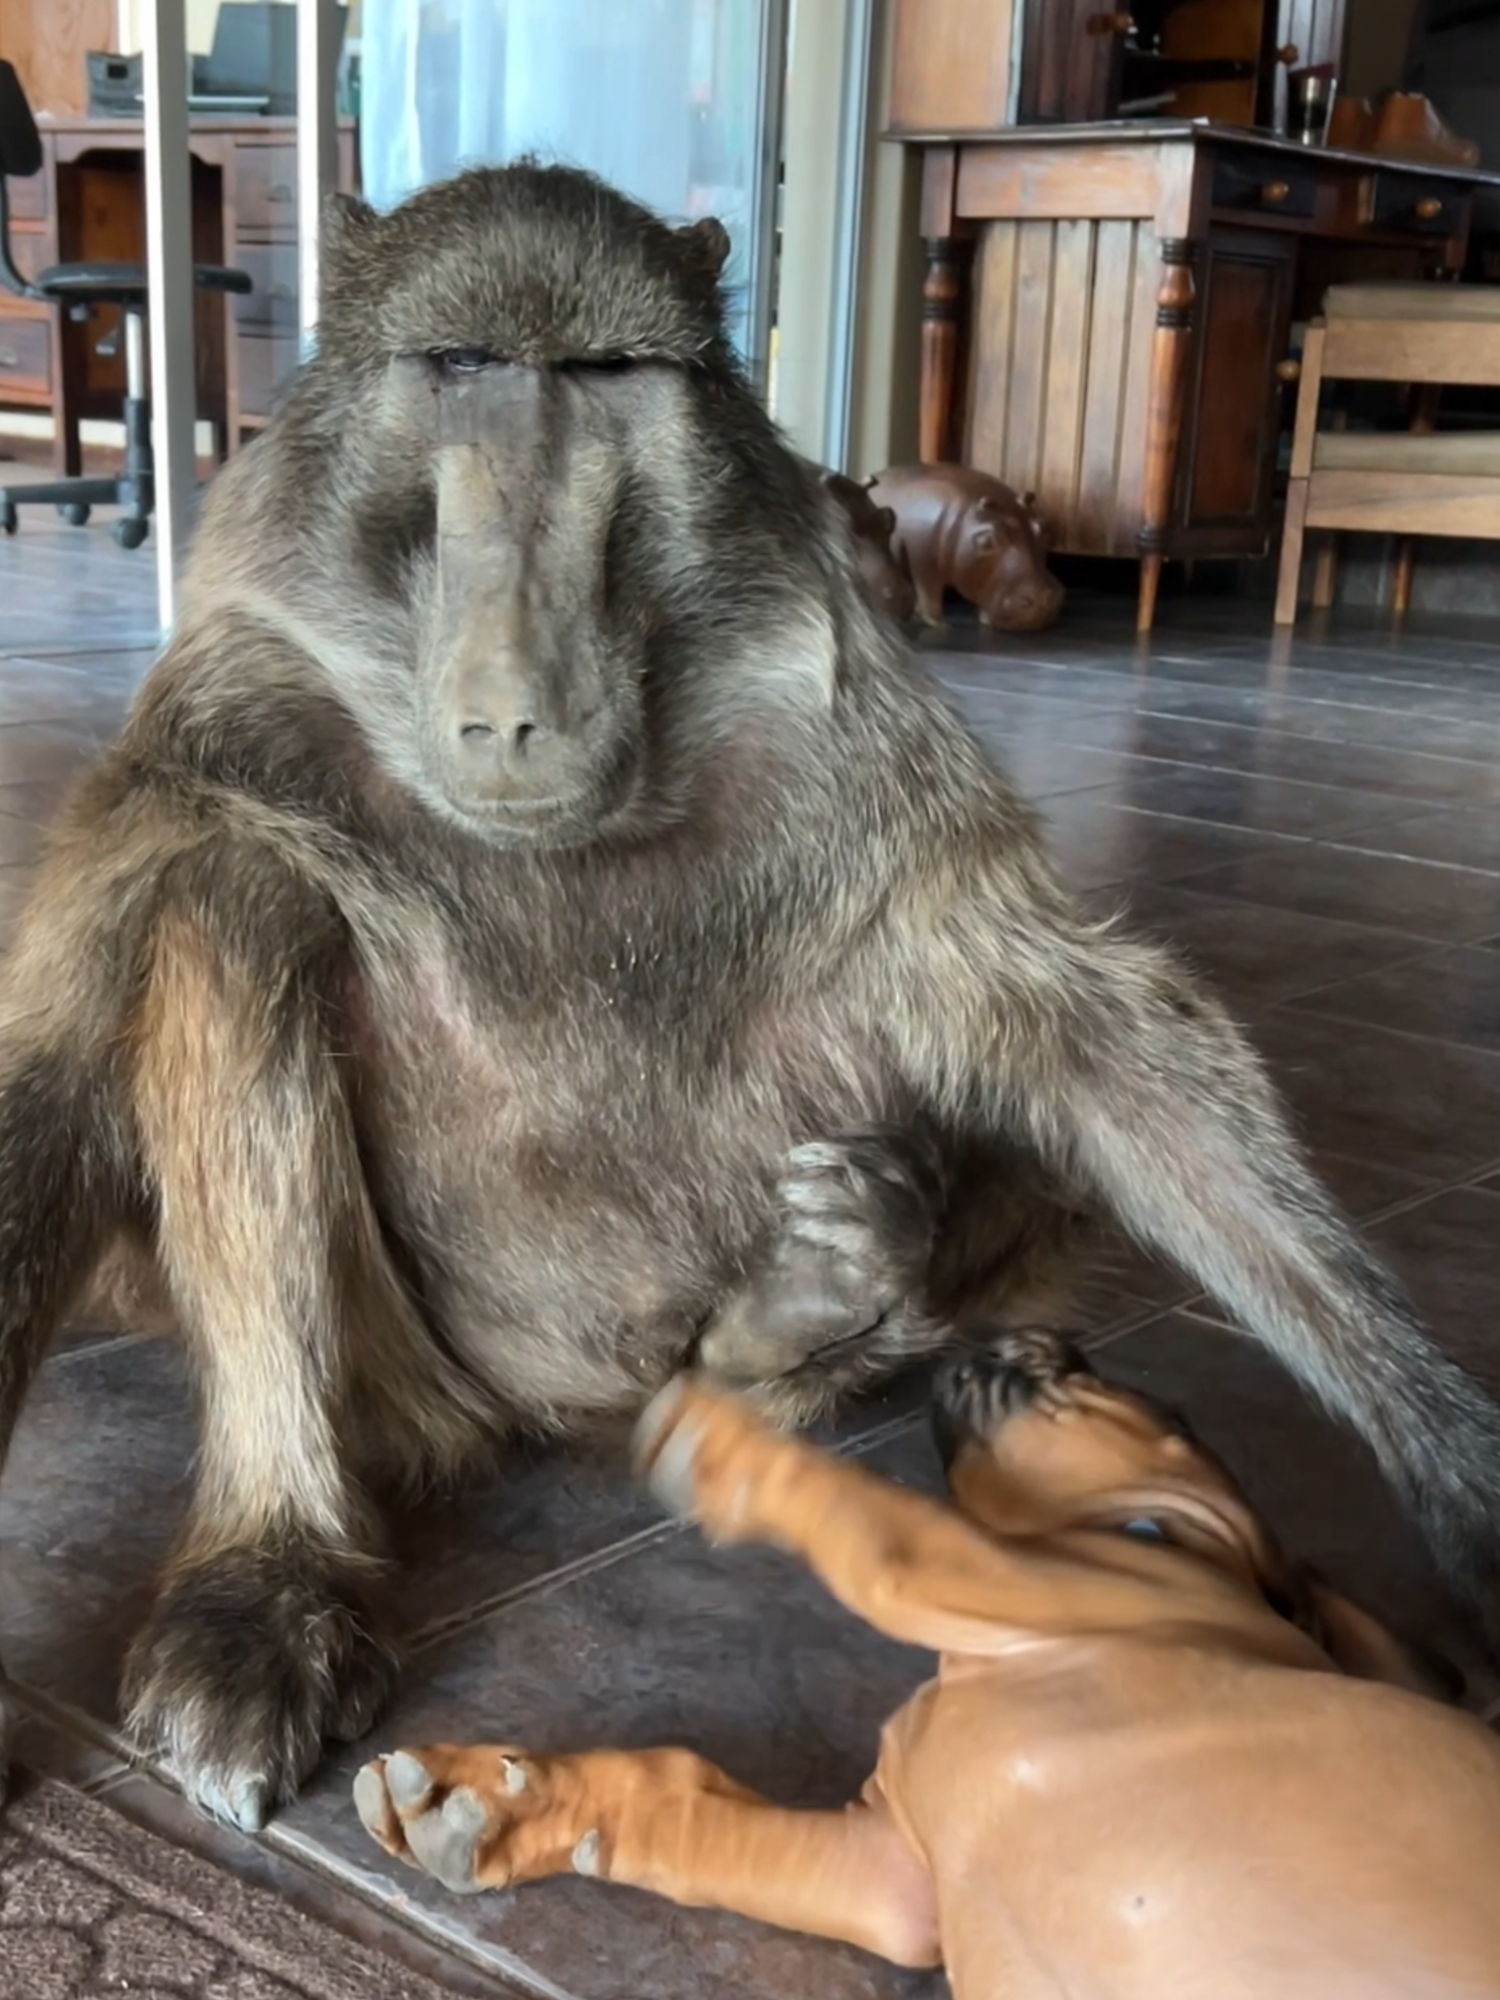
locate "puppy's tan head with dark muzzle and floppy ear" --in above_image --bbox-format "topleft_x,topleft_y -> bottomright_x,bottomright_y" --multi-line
932,1330 -> 1462,1700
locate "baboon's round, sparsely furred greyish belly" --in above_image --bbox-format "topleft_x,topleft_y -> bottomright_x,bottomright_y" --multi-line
340,950 -> 882,1402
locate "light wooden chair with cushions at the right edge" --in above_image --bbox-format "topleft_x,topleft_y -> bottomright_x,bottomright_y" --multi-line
1276,284 -> 1500,626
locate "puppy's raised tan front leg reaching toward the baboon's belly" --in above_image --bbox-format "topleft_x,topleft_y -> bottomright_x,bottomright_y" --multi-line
636,1376 -> 1104,1654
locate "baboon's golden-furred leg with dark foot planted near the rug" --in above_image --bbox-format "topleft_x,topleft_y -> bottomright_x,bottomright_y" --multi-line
124,900 -> 408,1828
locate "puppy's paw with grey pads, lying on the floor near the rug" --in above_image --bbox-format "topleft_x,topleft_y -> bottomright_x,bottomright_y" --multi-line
354,1744 -> 606,1896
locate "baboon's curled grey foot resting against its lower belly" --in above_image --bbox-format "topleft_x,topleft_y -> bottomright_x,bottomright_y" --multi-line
696,1128 -> 944,1422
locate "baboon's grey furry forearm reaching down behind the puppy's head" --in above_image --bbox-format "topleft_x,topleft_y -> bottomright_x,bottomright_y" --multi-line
1016,940 -> 1500,1648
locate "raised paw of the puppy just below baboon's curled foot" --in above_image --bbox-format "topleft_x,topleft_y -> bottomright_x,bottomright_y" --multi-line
634,1376 -> 812,1542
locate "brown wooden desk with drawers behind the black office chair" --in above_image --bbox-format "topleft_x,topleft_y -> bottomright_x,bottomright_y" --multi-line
0,118 -> 358,474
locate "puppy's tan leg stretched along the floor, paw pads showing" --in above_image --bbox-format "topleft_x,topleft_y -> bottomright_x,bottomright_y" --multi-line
354,1744 -> 940,1966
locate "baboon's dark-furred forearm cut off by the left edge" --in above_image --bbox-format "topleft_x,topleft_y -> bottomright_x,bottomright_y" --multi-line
0,1030 -> 118,1800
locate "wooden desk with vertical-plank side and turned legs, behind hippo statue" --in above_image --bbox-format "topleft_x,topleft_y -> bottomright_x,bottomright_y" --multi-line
888,120 -> 1500,632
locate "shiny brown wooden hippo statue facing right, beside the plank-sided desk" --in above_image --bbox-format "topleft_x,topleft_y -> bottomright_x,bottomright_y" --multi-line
870,466 -> 1062,632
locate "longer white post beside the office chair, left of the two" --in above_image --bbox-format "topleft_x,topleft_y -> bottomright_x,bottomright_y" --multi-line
140,0 -> 198,636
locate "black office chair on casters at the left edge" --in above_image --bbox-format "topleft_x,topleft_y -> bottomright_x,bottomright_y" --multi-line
0,62 -> 252,548
